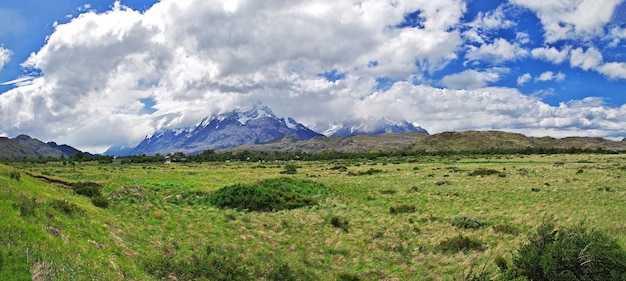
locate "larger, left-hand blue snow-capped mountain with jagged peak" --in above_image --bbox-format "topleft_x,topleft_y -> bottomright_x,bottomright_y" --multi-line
117,105 -> 321,155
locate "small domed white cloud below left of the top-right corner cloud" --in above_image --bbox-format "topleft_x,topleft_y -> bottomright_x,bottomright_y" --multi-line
465,38 -> 528,63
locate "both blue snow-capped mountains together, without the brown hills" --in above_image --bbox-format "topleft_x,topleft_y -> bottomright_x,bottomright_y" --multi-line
105,105 -> 427,156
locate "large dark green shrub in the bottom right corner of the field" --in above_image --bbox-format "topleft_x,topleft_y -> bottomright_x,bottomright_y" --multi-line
513,219 -> 626,280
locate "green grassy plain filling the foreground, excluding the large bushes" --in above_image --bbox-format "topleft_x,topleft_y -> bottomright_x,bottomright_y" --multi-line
0,154 -> 626,280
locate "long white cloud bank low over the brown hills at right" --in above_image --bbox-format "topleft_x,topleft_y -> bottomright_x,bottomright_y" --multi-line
357,83 -> 626,137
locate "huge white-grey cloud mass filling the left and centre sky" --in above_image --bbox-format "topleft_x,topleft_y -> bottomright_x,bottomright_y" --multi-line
0,0 -> 465,151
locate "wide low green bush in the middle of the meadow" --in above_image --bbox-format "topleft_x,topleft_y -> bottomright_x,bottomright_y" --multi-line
208,178 -> 328,212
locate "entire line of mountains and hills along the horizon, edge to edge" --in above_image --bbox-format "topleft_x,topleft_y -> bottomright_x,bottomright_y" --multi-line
0,105 -> 626,159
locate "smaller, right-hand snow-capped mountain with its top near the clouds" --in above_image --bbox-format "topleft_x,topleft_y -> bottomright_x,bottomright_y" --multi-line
324,117 -> 428,137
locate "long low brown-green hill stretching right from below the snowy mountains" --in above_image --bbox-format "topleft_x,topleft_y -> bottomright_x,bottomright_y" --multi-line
228,131 -> 626,153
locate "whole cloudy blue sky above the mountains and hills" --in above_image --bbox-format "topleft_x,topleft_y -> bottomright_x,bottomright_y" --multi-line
0,0 -> 626,153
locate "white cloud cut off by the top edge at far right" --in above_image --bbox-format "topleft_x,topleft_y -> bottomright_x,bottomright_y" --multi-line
511,0 -> 622,43
